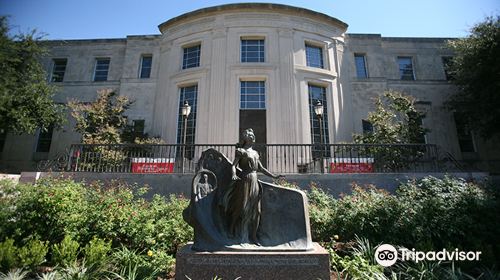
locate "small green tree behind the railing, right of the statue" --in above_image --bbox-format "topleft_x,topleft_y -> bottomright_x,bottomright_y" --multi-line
353,90 -> 428,144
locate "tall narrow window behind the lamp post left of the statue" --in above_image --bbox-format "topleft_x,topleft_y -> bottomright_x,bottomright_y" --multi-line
177,85 -> 198,159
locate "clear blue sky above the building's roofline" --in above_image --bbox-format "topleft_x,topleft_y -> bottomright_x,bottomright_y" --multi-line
0,0 -> 500,39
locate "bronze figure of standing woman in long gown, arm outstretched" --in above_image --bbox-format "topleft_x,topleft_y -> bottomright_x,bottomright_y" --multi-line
226,128 -> 281,244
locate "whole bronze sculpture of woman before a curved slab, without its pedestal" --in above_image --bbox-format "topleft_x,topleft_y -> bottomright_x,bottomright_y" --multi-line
183,129 -> 312,251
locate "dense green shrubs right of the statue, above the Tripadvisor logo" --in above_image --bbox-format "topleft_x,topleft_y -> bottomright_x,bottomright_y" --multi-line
308,176 -> 500,272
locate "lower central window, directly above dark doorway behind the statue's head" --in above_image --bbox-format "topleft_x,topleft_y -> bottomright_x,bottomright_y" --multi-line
240,81 -> 266,109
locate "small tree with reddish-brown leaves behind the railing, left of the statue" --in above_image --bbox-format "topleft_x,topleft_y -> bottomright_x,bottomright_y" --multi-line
68,89 -> 164,171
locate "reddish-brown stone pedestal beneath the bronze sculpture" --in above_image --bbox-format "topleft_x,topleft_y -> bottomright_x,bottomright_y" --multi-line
175,243 -> 330,280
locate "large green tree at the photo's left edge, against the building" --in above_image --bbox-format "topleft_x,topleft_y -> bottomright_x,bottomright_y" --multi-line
0,17 -> 64,133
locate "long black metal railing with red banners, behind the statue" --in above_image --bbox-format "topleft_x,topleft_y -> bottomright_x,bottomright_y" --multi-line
66,144 -> 440,174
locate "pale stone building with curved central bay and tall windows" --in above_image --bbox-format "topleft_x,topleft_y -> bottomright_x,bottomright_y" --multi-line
0,4 -> 500,171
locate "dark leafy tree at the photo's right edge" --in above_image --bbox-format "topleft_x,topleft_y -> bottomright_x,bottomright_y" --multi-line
448,16 -> 500,139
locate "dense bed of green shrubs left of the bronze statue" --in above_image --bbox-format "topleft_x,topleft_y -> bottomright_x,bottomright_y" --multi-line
0,179 -> 193,279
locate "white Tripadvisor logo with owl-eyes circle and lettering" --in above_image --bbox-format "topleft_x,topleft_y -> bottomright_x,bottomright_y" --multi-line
375,244 -> 481,267
